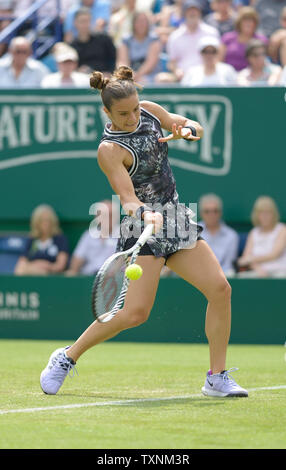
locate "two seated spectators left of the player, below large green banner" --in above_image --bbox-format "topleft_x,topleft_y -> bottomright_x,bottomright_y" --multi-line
14,200 -> 119,276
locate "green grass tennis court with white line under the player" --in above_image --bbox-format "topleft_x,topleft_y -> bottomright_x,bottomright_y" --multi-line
0,340 -> 286,449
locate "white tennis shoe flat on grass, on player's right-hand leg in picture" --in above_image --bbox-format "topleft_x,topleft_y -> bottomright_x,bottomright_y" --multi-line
202,367 -> 248,397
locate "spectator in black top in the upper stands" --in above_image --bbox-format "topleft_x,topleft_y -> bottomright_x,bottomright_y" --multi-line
71,8 -> 116,73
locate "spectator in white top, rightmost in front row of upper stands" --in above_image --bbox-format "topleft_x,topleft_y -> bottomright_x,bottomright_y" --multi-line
237,39 -> 281,86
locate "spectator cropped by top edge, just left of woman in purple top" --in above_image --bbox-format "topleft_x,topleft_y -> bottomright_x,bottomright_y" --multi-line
204,0 -> 236,36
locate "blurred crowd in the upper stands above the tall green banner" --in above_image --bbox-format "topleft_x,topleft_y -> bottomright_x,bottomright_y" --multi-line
0,0 -> 286,88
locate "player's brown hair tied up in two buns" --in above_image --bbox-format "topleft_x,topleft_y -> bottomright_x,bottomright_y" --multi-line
90,65 -> 138,110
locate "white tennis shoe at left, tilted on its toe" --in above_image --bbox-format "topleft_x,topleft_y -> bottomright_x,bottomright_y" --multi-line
40,346 -> 77,395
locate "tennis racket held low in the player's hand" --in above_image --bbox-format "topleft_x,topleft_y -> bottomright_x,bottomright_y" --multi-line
92,224 -> 154,323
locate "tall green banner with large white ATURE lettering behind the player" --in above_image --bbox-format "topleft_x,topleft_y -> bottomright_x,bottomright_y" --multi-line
0,87 -> 286,228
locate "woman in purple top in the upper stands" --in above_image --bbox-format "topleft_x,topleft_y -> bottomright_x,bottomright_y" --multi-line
221,7 -> 268,71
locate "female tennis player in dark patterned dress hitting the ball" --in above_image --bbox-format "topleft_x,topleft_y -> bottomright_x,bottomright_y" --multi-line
40,66 -> 248,397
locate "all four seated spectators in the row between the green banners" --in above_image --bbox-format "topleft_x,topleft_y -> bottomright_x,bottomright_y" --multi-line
8,193 -> 286,278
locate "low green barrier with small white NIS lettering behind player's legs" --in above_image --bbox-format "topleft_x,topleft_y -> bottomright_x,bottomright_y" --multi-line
0,276 -> 286,345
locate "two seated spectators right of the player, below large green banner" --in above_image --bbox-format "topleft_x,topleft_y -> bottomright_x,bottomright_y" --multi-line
199,194 -> 286,277
